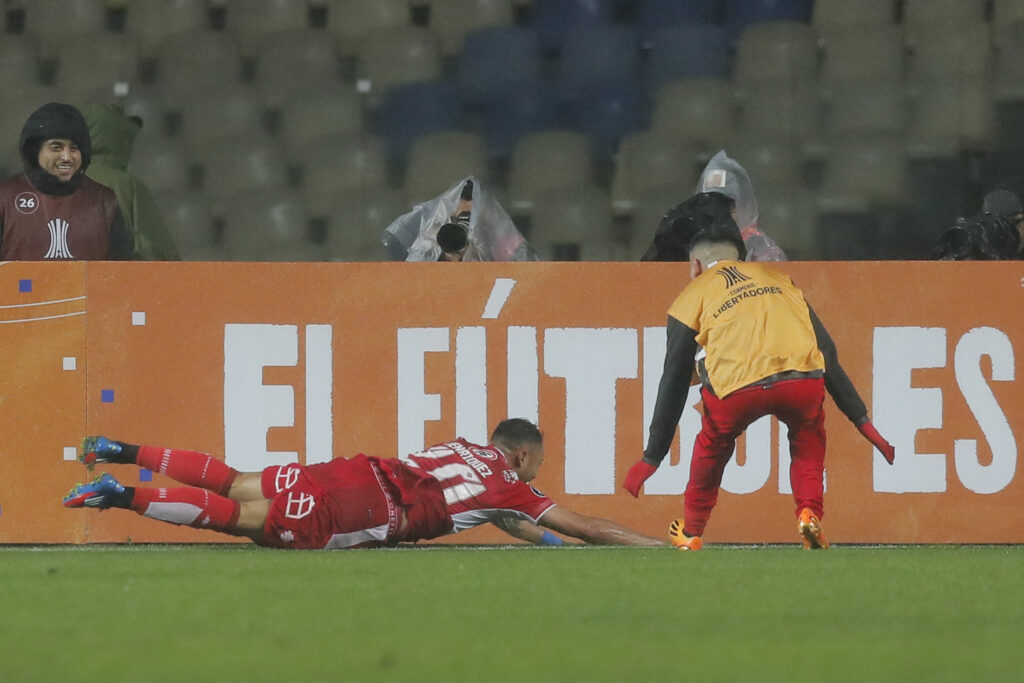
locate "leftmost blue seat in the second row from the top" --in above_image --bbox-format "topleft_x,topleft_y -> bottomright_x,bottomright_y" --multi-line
458,27 -> 541,104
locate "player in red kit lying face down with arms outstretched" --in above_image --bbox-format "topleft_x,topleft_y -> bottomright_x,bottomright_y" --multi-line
63,418 -> 665,549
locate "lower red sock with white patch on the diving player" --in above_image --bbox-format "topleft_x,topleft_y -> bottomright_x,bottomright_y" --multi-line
129,486 -> 241,533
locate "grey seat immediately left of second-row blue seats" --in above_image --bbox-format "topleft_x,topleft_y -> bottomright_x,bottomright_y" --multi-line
356,26 -> 441,99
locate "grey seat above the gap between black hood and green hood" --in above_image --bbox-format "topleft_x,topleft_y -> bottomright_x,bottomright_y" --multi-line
54,33 -> 139,99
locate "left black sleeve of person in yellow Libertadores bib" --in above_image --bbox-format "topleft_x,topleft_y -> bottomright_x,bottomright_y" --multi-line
643,316 -> 697,466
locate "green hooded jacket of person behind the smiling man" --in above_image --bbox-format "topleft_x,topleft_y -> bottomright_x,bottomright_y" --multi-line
82,103 -> 181,261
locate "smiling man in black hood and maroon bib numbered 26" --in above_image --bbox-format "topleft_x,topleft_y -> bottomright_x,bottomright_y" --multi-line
0,102 -> 134,261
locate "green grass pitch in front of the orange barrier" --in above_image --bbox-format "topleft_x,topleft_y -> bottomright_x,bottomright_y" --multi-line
0,545 -> 1024,683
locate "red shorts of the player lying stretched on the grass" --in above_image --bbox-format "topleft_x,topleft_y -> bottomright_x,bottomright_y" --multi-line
259,455 -> 401,550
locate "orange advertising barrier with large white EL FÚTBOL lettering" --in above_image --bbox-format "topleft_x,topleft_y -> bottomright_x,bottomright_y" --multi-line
0,262 -> 1024,543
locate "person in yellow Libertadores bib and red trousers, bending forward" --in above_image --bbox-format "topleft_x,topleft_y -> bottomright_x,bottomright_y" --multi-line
625,217 -> 895,550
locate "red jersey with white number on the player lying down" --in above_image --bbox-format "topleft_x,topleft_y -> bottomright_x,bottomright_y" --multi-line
400,438 -> 555,533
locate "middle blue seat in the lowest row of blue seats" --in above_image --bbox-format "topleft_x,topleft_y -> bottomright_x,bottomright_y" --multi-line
483,80 -> 561,158
